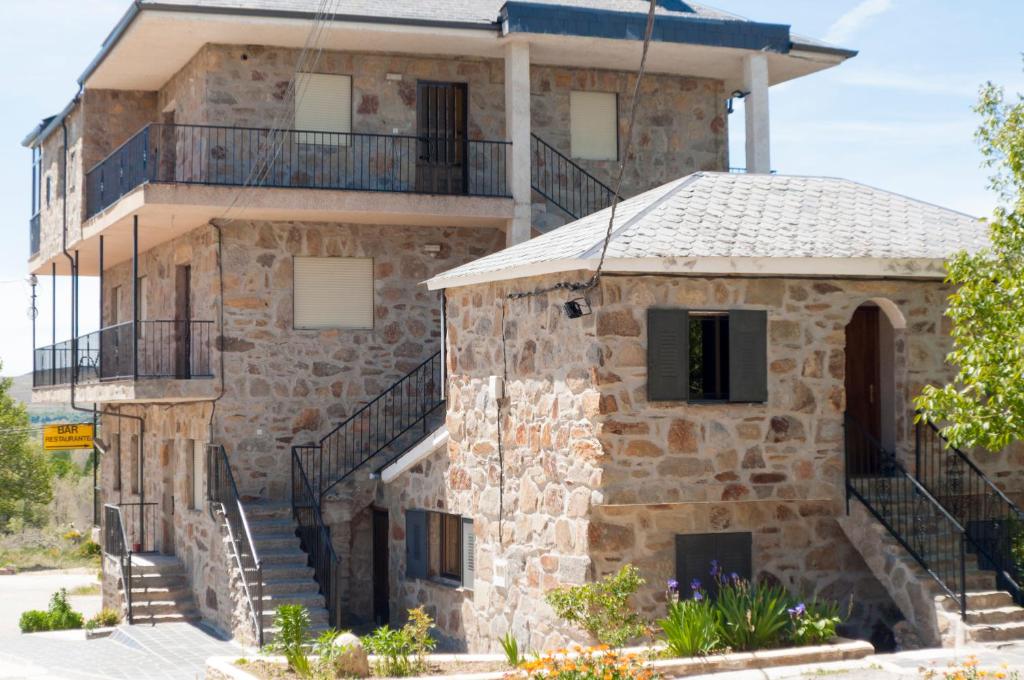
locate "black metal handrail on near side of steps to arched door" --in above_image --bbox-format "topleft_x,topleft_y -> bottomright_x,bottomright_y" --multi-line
845,415 -> 968,617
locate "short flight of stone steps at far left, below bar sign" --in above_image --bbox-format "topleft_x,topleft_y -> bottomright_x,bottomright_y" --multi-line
129,553 -> 201,626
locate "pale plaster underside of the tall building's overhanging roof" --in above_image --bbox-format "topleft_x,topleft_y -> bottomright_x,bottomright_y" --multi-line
84,10 -> 843,91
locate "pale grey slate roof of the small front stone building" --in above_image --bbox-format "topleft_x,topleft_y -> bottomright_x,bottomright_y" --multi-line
430,172 -> 987,288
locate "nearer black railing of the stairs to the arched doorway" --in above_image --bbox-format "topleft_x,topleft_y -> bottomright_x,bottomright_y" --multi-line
844,414 -> 968,618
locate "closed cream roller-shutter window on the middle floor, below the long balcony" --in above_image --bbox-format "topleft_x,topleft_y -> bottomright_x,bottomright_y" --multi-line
294,257 -> 374,330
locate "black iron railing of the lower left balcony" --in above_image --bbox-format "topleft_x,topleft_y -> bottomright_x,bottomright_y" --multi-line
32,321 -> 213,387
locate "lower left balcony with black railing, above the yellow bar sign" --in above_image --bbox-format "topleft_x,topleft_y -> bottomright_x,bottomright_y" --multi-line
32,321 -> 214,401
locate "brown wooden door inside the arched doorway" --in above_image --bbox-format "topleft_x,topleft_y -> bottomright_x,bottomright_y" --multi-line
846,306 -> 882,475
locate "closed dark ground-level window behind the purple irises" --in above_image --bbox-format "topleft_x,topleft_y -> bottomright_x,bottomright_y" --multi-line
676,532 -> 753,594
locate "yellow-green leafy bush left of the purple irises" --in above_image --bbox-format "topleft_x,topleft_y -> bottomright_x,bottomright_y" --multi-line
545,564 -> 647,647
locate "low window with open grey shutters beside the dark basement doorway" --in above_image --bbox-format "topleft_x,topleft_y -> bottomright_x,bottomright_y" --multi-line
406,510 -> 476,588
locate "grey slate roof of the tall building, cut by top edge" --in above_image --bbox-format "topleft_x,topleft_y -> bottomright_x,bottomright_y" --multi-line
141,0 -> 745,26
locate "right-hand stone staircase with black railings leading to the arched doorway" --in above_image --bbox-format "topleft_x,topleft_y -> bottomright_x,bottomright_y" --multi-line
840,418 -> 1024,646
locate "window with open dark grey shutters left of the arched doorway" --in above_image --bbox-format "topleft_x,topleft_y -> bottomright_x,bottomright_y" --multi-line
647,308 -> 768,402
